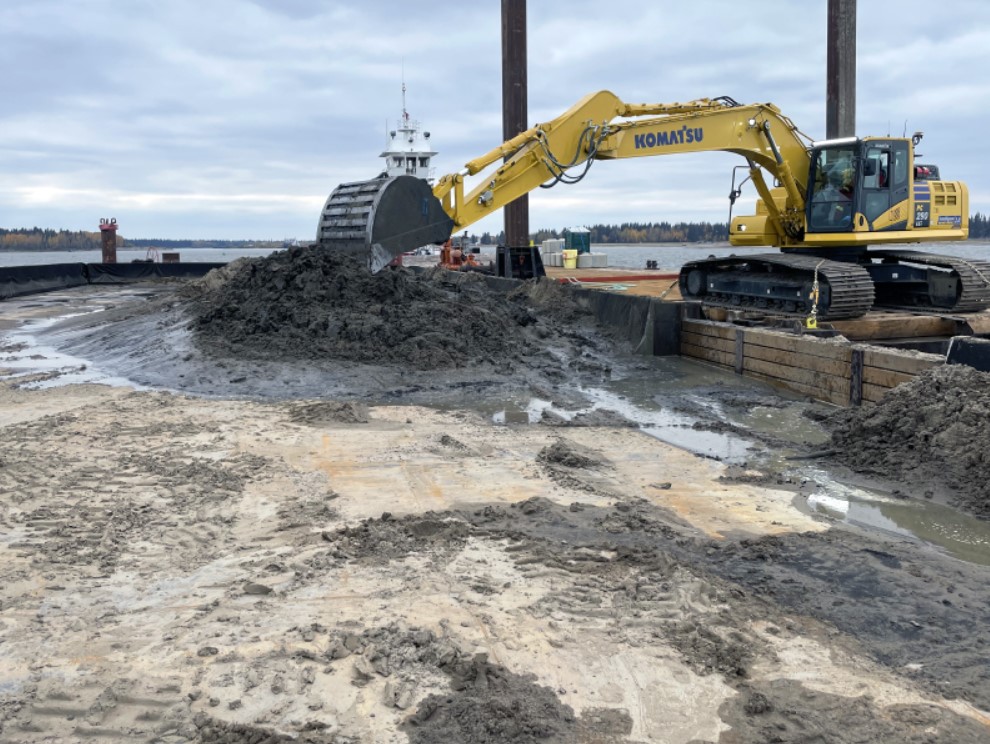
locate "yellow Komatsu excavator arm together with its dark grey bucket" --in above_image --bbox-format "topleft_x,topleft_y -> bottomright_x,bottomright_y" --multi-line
317,91 -> 810,271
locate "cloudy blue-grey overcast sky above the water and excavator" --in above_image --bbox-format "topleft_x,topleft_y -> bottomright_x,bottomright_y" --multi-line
0,0 -> 990,240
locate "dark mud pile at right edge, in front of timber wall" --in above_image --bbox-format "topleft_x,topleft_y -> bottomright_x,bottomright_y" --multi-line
829,365 -> 990,519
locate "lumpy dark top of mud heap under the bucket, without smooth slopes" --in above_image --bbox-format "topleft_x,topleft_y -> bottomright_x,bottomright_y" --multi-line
185,246 -> 604,370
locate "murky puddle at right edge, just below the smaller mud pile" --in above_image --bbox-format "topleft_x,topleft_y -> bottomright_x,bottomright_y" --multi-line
799,469 -> 990,566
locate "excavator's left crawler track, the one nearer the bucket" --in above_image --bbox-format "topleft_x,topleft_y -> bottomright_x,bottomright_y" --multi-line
681,253 -> 873,320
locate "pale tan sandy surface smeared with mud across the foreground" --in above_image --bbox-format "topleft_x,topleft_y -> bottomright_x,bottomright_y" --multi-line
0,386 -> 990,742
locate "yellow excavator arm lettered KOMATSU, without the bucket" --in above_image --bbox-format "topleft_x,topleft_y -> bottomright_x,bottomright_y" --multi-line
433,91 -> 809,240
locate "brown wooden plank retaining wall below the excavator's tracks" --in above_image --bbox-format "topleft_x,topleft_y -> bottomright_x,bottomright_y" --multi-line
680,319 -> 945,406
